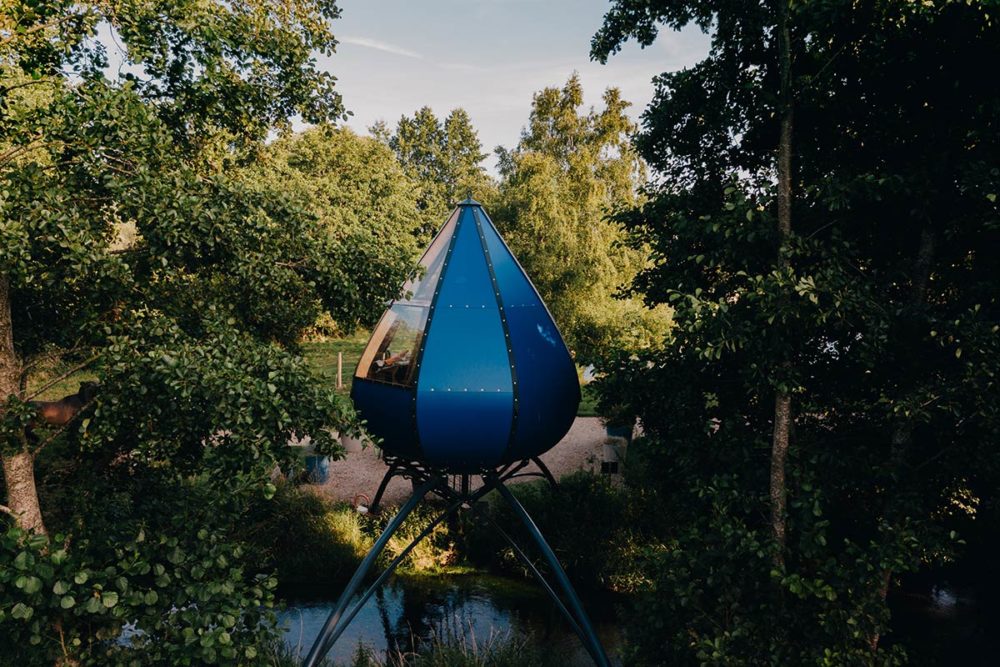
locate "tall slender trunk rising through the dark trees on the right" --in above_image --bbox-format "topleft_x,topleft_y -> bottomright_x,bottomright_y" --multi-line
770,0 -> 793,568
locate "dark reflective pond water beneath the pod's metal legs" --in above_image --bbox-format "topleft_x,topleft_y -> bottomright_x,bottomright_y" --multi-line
279,574 -> 620,667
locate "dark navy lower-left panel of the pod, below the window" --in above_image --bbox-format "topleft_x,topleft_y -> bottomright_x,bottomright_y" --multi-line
351,377 -> 421,460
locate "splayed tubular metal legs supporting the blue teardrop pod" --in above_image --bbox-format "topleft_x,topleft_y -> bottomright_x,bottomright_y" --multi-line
302,459 -> 611,667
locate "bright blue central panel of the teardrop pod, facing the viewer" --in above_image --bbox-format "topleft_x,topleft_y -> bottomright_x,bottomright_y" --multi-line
417,206 -> 514,470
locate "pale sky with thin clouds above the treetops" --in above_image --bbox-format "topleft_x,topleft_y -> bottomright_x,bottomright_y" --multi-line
319,0 -> 708,172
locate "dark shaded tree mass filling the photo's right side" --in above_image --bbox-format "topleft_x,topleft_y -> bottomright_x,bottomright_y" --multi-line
592,0 -> 1000,664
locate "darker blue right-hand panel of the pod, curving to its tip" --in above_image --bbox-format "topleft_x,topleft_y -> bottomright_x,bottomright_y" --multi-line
474,208 -> 580,460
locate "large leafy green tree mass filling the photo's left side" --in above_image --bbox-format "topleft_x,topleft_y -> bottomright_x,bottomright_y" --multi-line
0,0 -> 392,665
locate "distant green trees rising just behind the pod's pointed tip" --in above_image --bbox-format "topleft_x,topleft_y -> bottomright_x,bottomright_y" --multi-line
372,107 -> 495,234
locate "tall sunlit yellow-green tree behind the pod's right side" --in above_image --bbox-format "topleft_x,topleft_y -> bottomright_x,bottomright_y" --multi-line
494,75 -> 669,363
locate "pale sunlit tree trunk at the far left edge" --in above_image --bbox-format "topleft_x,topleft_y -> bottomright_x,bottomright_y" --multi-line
0,276 -> 45,533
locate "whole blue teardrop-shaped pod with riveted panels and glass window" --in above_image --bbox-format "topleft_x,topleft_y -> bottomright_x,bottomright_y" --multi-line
351,199 -> 580,473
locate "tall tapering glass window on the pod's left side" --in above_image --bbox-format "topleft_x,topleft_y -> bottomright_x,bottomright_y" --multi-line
355,211 -> 458,387
